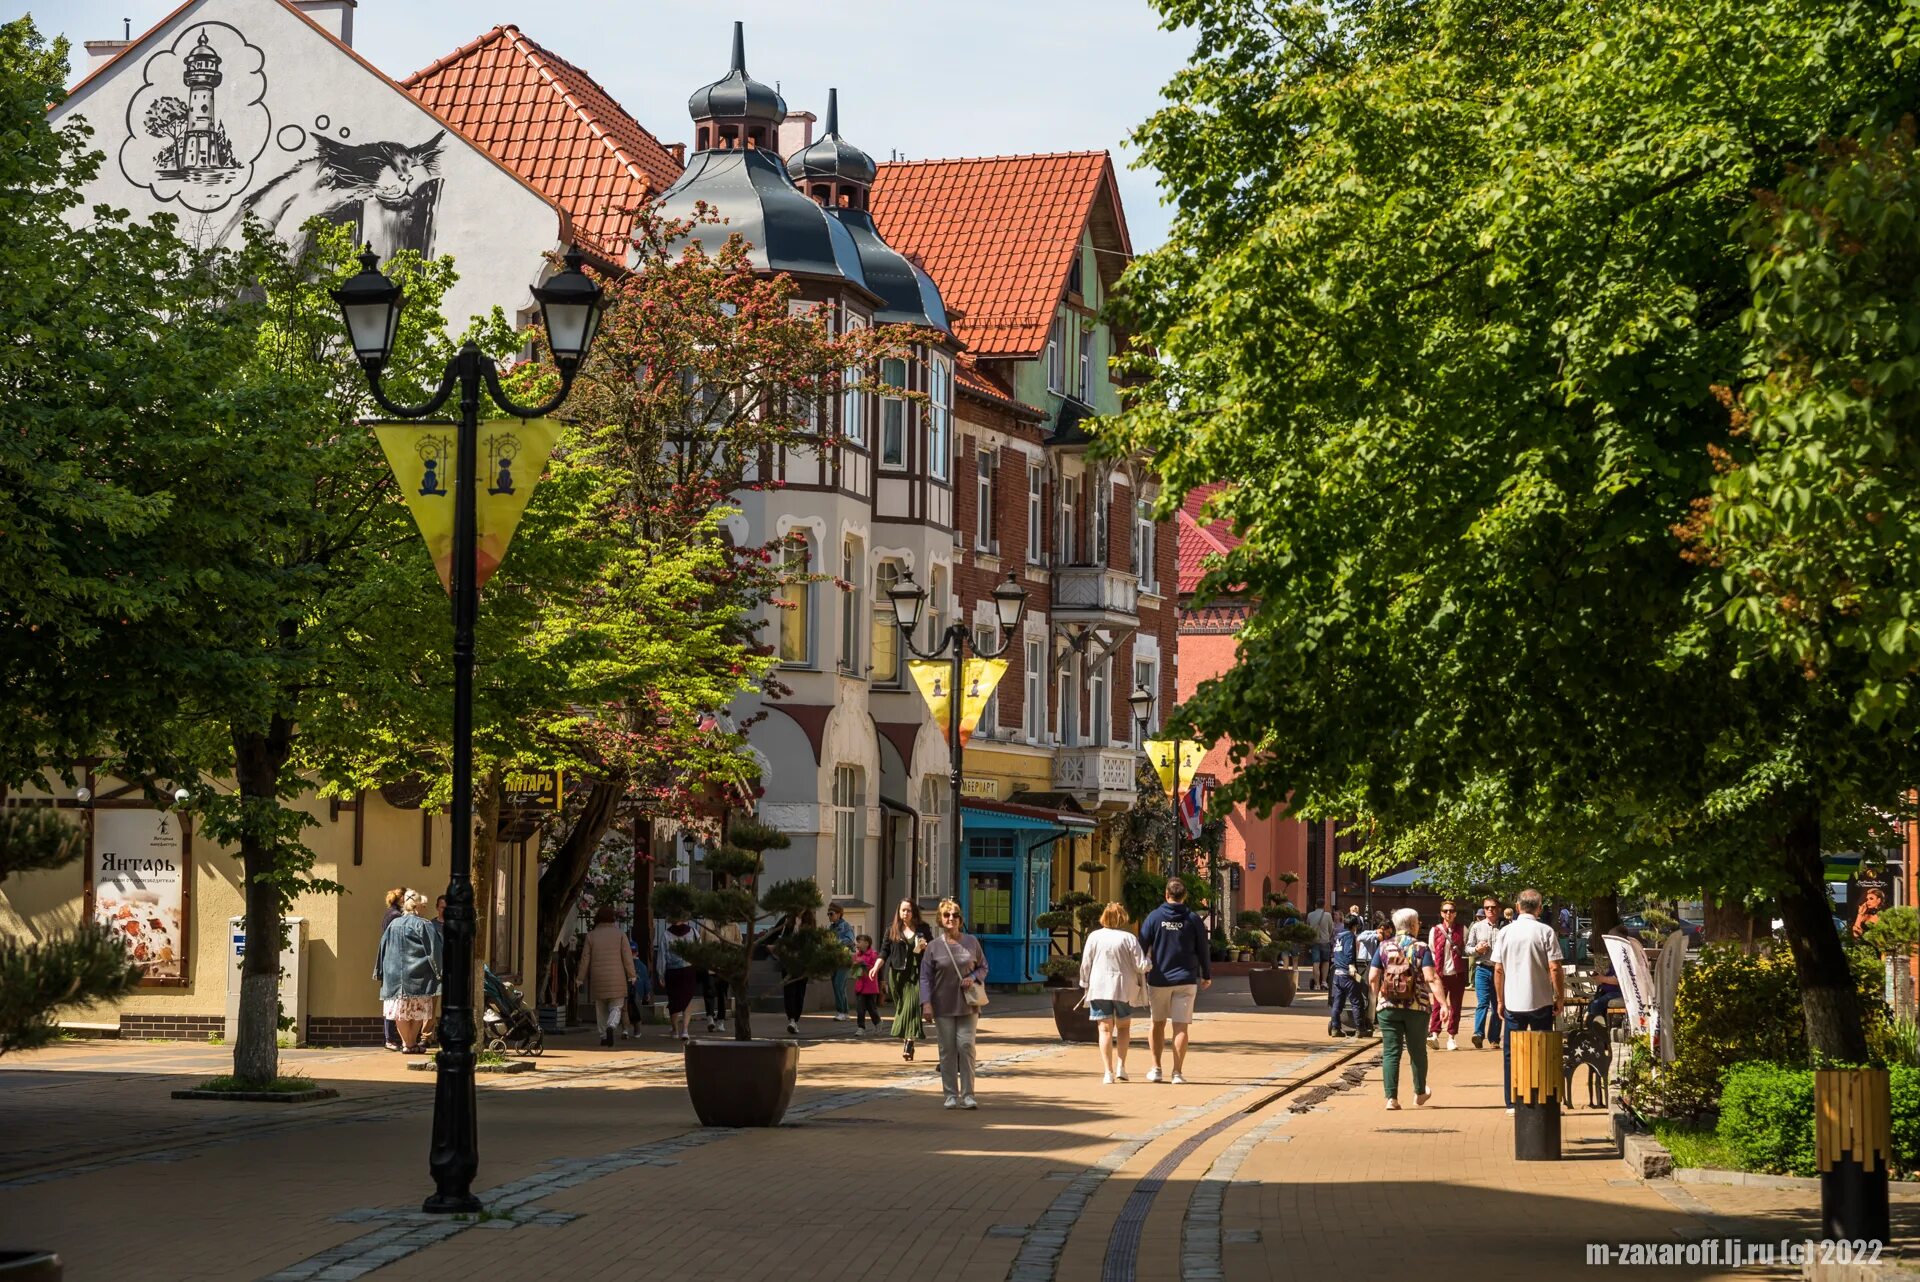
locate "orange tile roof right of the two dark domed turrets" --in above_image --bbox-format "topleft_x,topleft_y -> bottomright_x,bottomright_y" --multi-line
872,152 -> 1129,359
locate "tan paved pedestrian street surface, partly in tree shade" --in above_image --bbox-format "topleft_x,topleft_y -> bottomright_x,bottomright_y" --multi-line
0,981 -> 1920,1282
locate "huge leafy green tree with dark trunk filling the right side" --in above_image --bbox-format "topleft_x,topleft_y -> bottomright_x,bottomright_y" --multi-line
1119,0 -> 1920,1059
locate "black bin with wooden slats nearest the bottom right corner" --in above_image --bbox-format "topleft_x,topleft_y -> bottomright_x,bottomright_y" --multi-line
1812,1069 -> 1893,1244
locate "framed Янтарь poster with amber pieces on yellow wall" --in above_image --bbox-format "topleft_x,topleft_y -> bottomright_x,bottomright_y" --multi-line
88,808 -> 188,983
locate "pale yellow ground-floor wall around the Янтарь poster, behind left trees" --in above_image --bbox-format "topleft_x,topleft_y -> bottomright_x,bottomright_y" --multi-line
0,783 -> 538,1042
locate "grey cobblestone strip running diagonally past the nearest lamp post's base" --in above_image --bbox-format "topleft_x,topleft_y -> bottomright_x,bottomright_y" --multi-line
263,1046 -> 1066,1282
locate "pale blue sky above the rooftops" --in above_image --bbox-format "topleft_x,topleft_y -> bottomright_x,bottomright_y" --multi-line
33,0 -> 1190,251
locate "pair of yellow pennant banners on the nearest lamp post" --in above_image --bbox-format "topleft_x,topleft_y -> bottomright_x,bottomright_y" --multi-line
374,418 -> 561,593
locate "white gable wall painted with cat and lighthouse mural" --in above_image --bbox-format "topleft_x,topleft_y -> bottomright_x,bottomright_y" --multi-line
52,0 -> 563,332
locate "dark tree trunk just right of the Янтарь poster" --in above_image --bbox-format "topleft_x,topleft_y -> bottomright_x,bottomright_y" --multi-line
232,716 -> 294,1086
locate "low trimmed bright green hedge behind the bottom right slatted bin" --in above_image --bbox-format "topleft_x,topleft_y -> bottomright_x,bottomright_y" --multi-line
1715,1063 -> 1920,1176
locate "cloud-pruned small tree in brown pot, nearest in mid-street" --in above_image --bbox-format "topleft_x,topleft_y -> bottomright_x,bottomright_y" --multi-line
653,816 -> 852,1127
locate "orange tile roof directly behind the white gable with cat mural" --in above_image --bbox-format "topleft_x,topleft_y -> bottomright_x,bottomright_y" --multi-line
401,25 -> 682,263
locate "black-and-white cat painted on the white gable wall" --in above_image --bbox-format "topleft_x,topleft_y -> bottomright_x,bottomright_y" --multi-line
219,129 -> 447,257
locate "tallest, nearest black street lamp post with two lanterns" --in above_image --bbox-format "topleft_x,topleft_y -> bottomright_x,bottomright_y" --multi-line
332,249 -> 601,1213
